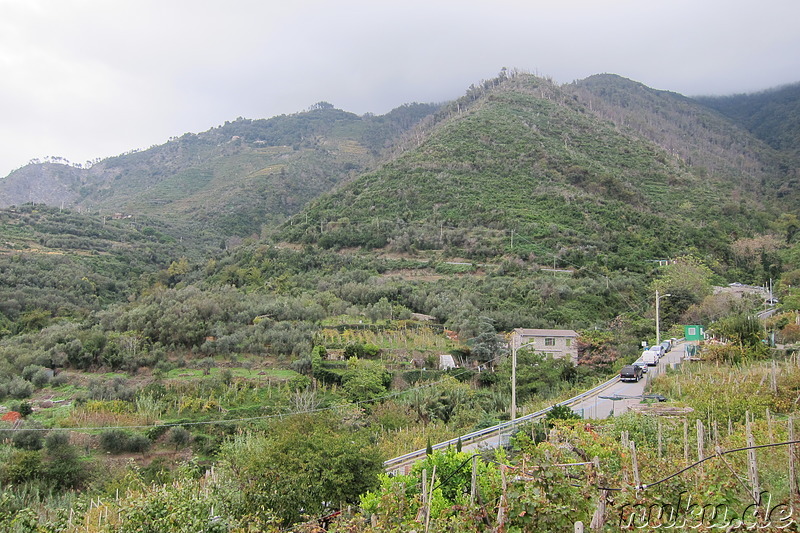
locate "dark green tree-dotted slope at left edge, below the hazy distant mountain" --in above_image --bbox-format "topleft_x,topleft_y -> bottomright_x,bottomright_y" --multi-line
0,204 -> 186,337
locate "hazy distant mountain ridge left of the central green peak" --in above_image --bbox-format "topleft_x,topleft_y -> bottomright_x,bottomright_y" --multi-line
0,102 -> 435,237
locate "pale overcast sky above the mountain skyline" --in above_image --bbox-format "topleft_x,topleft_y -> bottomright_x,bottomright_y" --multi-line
0,0 -> 800,176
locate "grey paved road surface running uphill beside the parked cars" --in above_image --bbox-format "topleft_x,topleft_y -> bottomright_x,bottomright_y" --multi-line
572,342 -> 686,418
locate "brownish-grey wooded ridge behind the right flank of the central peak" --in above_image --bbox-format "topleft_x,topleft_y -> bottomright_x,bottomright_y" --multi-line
565,74 -> 800,208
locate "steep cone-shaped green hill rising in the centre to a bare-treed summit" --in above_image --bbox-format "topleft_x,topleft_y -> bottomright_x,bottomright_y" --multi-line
284,73 -> 770,268
